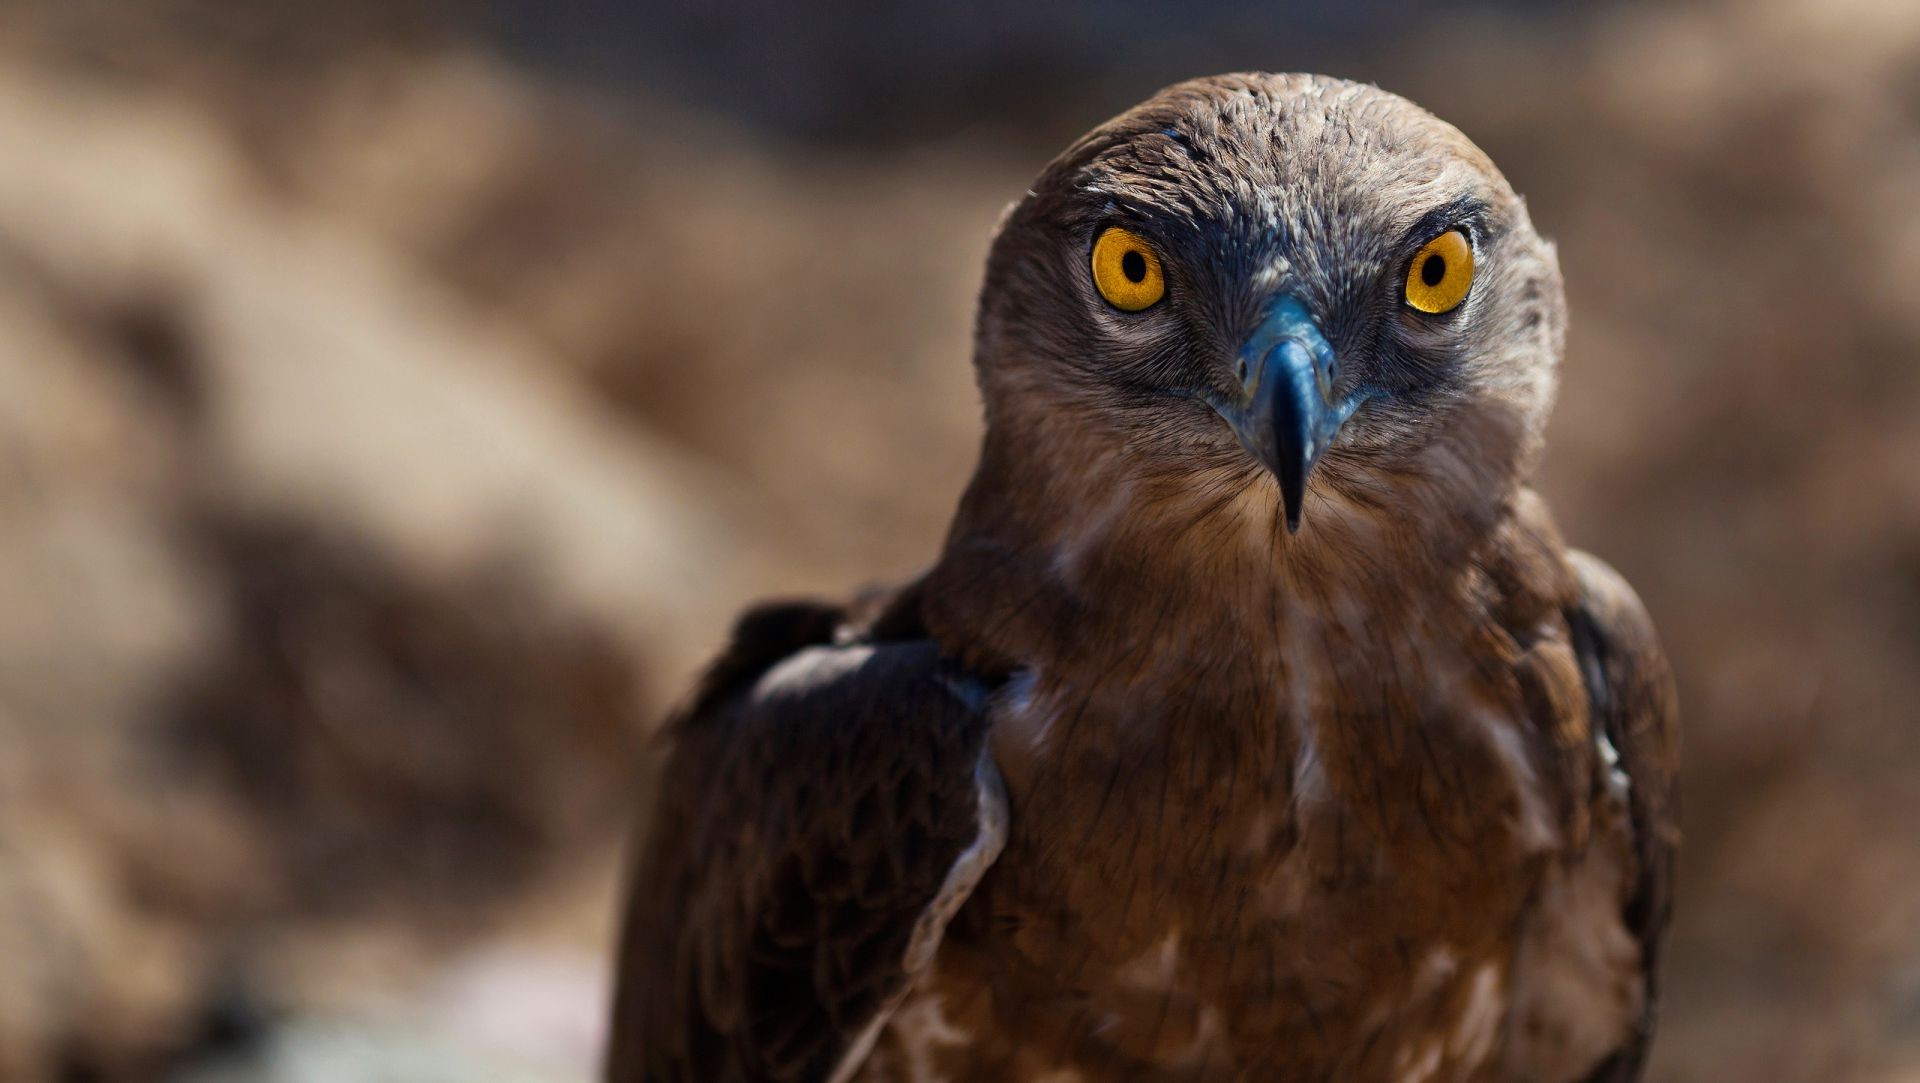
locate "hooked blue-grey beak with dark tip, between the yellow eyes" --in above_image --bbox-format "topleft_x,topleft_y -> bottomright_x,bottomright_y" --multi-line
1213,296 -> 1359,532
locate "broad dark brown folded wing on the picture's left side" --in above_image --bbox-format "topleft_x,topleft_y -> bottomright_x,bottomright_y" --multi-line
607,605 -> 1006,1083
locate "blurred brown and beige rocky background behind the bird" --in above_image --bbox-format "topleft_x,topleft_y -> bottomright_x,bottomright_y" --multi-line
0,0 -> 1920,1083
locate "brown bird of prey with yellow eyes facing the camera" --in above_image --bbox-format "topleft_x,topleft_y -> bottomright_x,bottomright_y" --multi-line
609,75 -> 1678,1083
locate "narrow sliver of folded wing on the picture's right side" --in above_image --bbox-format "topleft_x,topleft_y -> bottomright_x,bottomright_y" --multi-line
1567,551 -> 1680,1083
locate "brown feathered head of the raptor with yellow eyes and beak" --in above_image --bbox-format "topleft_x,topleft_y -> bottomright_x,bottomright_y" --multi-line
975,75 -> 1565,545
